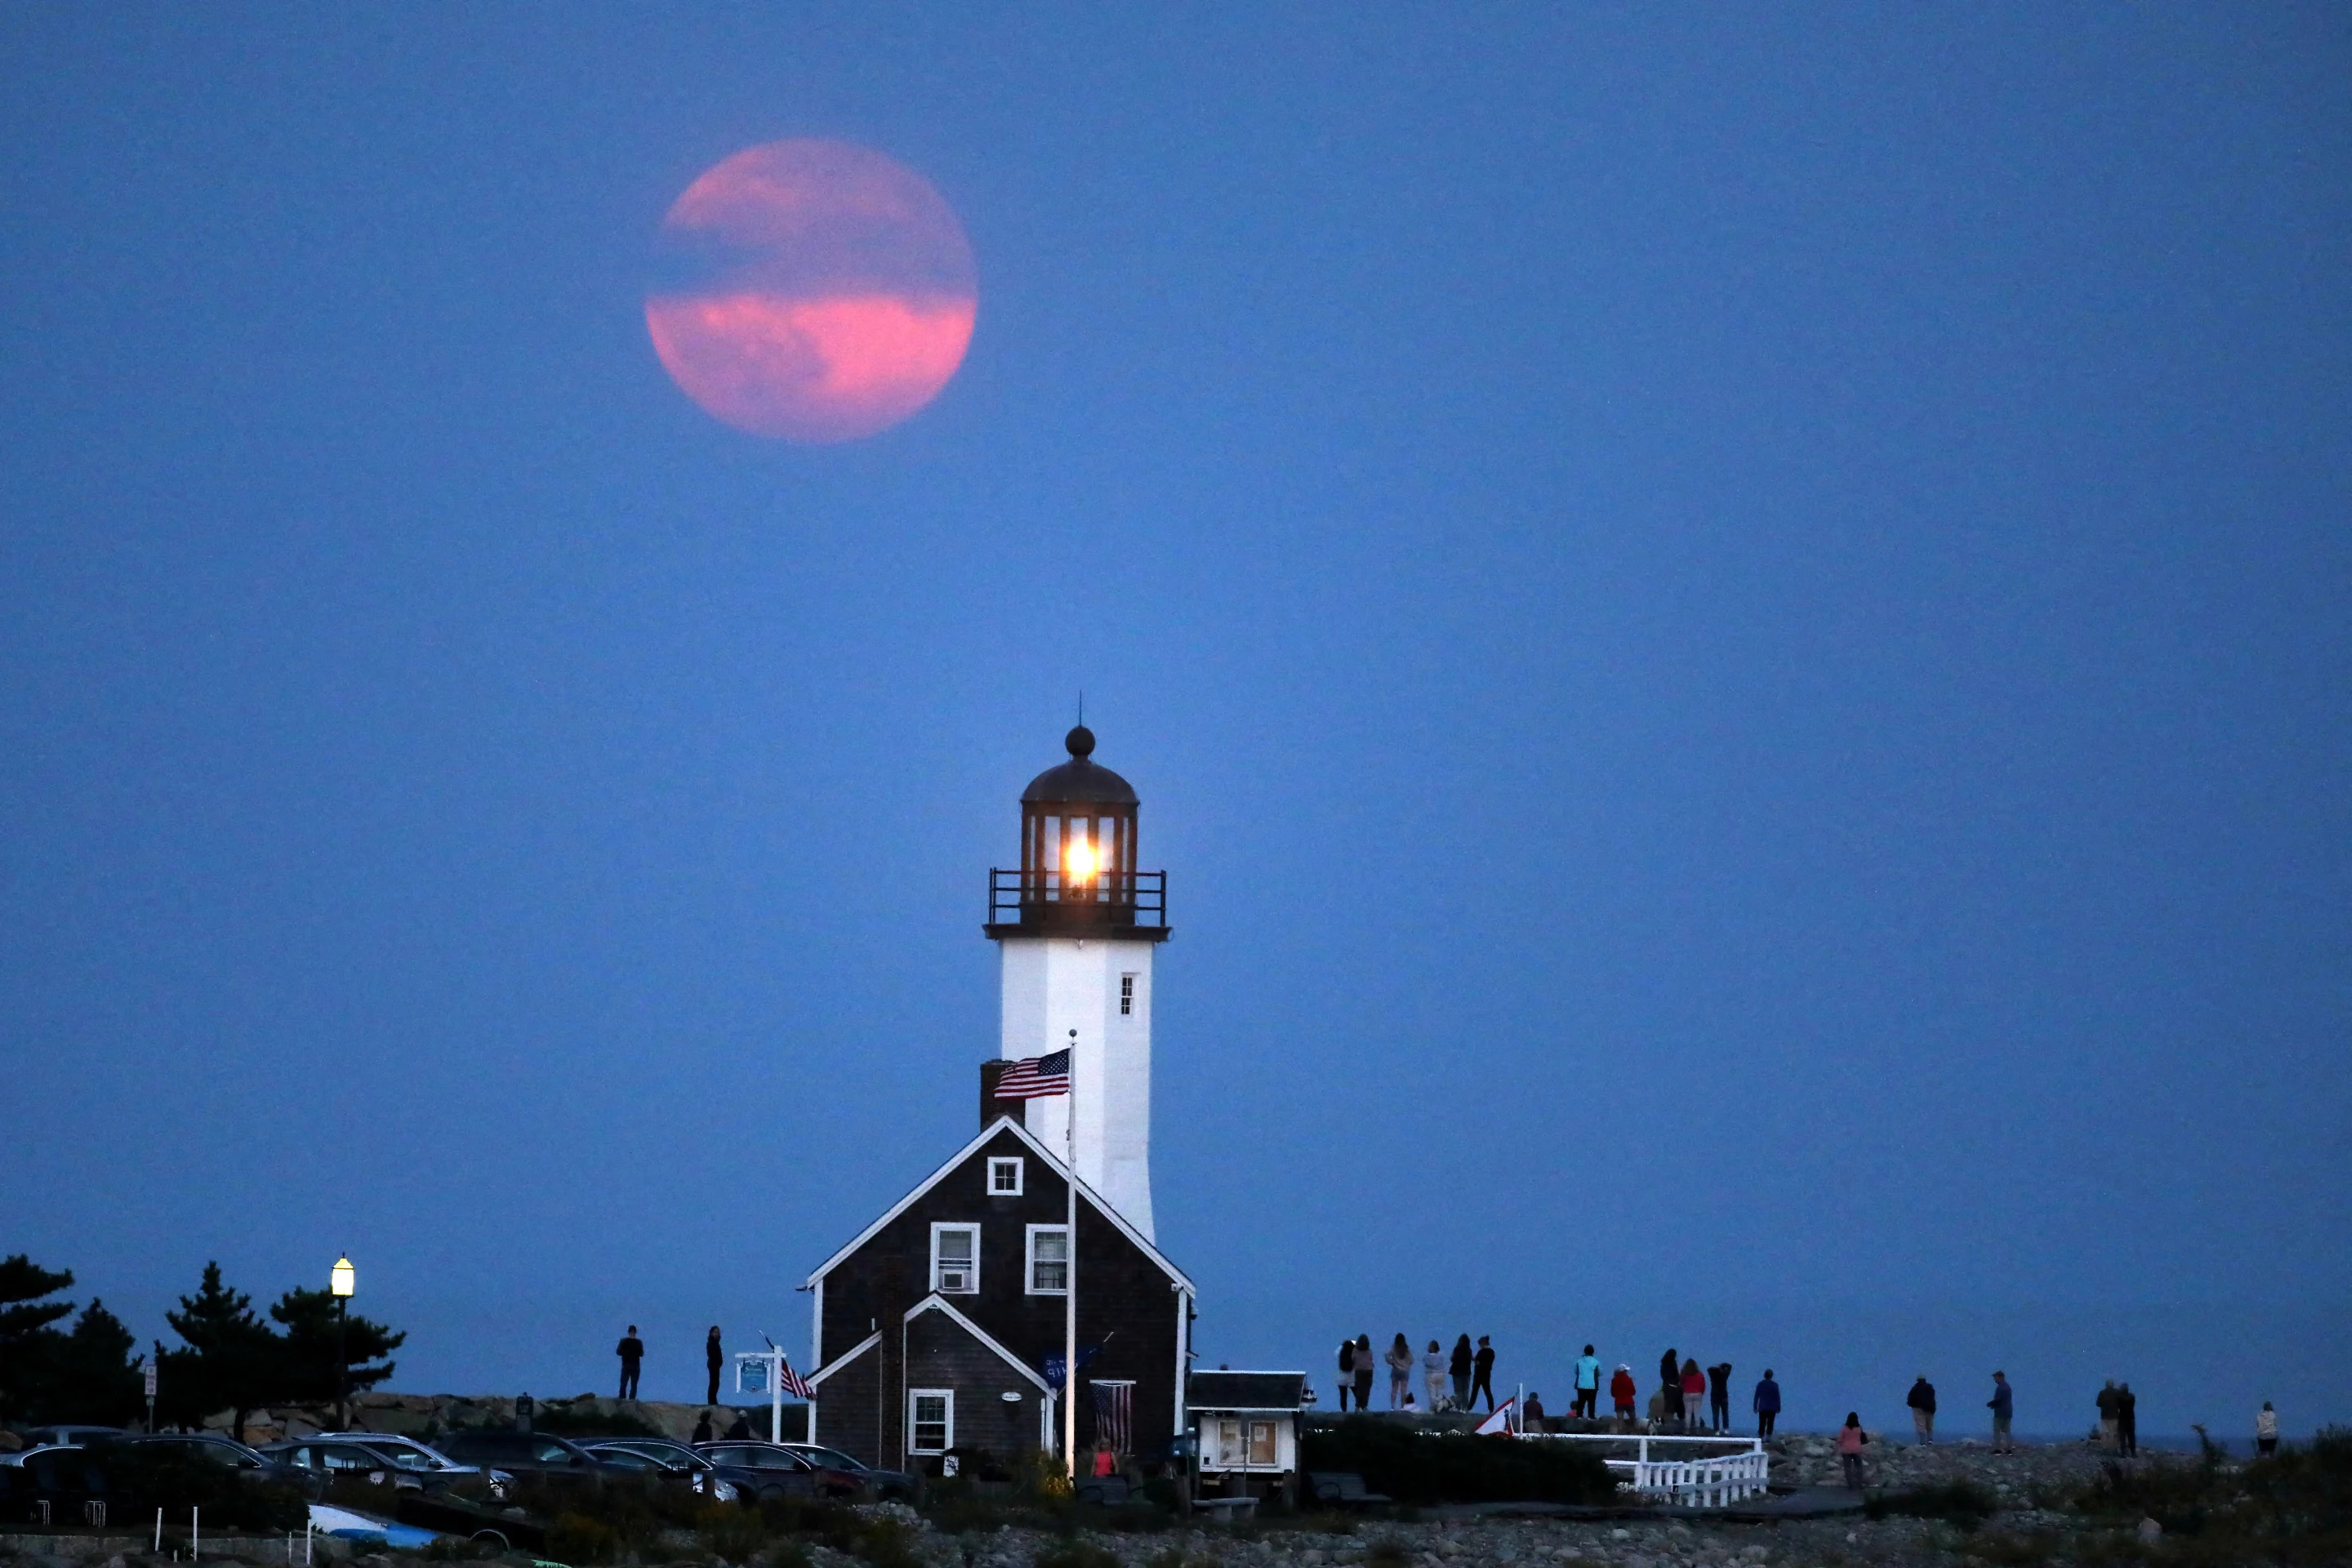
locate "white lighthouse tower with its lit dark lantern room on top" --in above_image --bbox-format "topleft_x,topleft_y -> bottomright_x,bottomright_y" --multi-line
983,724 -> 1169,1239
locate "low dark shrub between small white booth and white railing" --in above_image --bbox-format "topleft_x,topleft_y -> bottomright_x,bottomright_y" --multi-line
1298,1415 -> 1616,1502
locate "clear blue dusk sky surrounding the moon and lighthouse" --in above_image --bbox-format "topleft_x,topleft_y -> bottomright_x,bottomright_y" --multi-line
0,5 -> 2352,1432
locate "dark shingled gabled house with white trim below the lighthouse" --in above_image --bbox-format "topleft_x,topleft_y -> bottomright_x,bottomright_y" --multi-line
807,1114 -> 1195,1472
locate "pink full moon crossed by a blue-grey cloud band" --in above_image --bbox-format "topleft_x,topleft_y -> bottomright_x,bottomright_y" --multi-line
644,139 -> 981,442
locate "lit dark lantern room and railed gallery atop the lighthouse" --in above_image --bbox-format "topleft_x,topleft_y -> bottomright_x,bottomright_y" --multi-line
988,724 -> 1169,940
